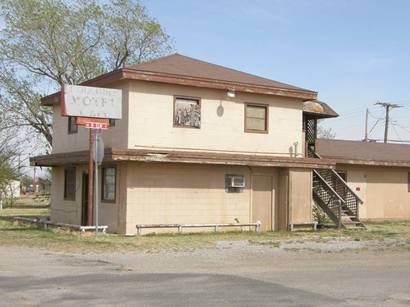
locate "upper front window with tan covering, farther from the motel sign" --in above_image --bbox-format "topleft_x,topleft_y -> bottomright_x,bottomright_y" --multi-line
245,103 -> 268,133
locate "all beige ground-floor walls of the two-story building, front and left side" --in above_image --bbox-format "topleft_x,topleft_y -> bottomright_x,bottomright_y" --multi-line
51,162 -> 311,234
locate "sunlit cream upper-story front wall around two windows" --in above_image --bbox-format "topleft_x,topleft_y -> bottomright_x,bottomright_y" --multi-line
128,81 -> 302,156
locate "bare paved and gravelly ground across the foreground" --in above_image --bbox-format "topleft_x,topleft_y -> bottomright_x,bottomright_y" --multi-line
0,240 -> 410,306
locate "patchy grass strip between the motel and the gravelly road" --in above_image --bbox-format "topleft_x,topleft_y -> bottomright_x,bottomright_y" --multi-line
0,201 -> 410,252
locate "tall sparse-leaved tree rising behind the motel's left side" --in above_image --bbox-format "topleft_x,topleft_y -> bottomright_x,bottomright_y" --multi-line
0,0 -> 173,146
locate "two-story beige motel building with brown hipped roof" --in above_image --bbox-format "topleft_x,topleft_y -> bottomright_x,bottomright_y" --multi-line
32,54 -> 337,234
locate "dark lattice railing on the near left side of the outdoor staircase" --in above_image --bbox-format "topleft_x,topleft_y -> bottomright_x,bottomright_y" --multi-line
313,170 -> 346,228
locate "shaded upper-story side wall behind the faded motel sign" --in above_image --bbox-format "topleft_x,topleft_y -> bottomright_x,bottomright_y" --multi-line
52,81 -> 129,153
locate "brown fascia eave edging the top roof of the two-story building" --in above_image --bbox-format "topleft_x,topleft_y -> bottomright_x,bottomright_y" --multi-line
41,68 -> 317,106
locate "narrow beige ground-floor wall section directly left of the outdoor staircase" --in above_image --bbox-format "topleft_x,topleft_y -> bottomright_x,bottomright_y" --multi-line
288,169 -> 312,224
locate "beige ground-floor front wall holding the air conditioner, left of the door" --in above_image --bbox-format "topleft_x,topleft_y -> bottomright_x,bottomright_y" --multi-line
126,163 -> 250,234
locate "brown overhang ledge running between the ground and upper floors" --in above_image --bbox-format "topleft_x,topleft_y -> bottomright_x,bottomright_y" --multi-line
30,148 -> 335,169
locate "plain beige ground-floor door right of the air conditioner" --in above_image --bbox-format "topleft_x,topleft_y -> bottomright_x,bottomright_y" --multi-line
252,175 -> 274,231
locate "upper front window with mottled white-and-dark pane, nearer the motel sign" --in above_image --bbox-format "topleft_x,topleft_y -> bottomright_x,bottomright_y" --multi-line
174,97 -> 201,128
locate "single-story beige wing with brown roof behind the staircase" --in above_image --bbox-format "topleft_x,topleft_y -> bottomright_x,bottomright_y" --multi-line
316,139 -> 410,220
